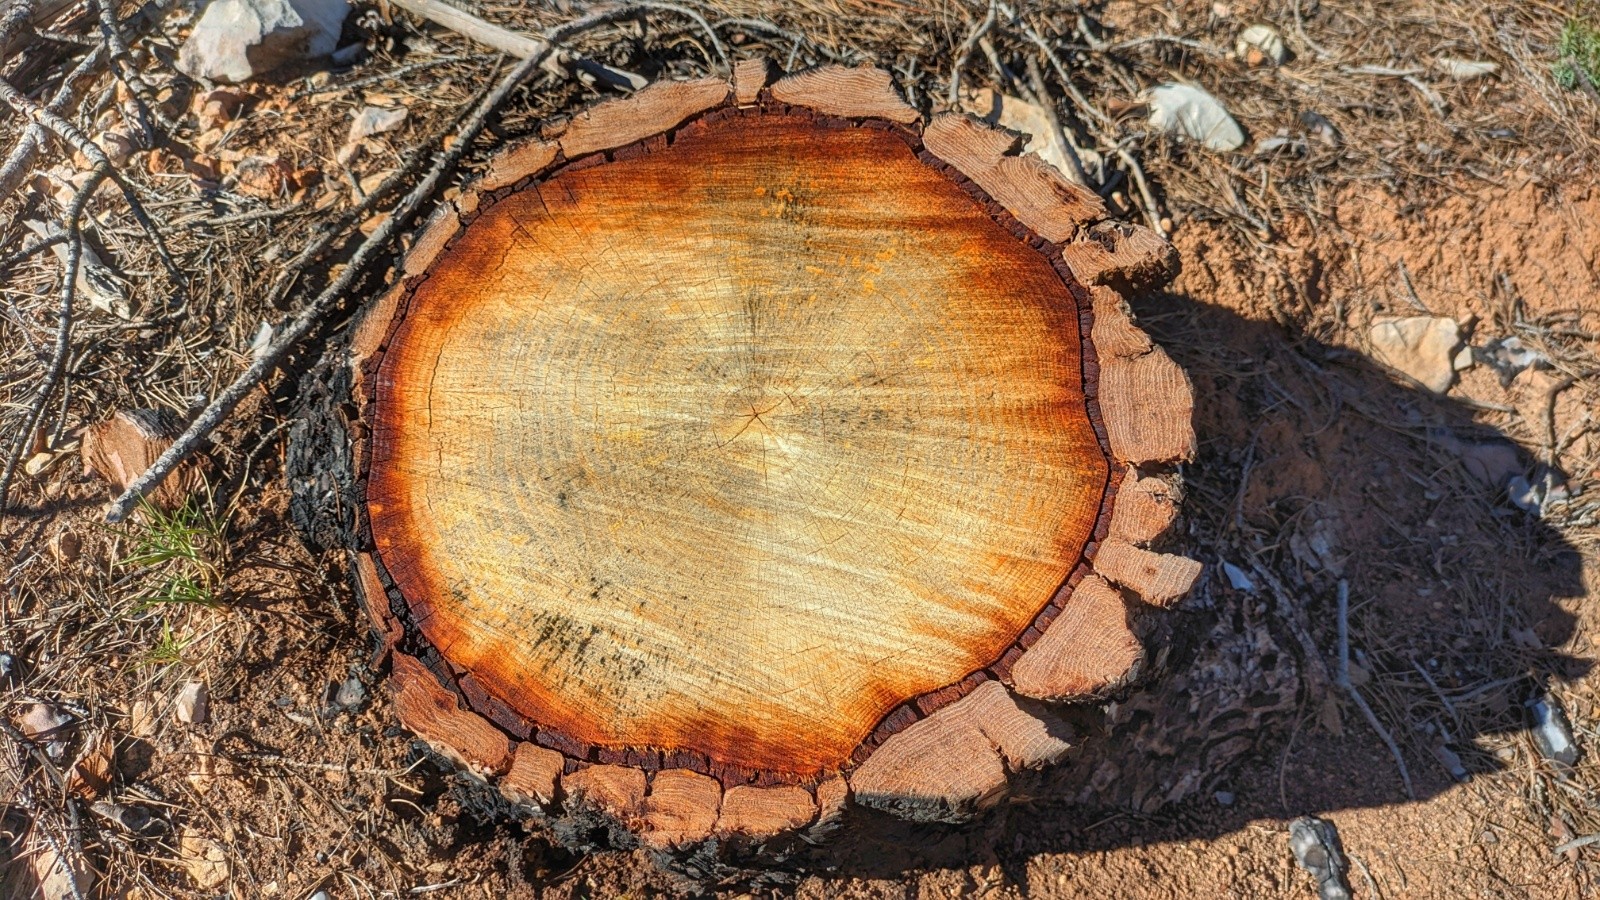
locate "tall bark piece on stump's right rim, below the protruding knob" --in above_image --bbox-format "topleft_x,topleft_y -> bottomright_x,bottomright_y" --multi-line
1091,288 -> 1195,464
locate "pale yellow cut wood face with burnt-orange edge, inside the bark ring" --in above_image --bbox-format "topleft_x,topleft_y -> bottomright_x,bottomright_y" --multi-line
368,115 -> 1107,778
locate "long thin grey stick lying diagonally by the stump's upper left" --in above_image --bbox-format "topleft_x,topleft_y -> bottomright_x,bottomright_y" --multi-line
106,6 -> 634,524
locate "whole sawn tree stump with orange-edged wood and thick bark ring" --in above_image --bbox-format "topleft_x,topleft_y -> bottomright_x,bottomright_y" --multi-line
331,61 -> 1198,850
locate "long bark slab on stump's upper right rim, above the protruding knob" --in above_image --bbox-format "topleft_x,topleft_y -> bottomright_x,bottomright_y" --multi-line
922,112 -> 1106,243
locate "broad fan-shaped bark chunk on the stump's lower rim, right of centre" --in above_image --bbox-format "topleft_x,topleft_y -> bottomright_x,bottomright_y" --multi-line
850,701 -> 1006,823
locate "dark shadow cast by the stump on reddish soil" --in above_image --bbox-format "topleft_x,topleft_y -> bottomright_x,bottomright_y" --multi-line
806,283 -> 1590,884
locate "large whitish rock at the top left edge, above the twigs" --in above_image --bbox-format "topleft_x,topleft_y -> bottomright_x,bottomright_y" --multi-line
178,0 -> 350,82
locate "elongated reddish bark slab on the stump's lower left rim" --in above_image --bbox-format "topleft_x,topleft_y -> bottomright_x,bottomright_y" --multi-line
390,653 -> 510,777
